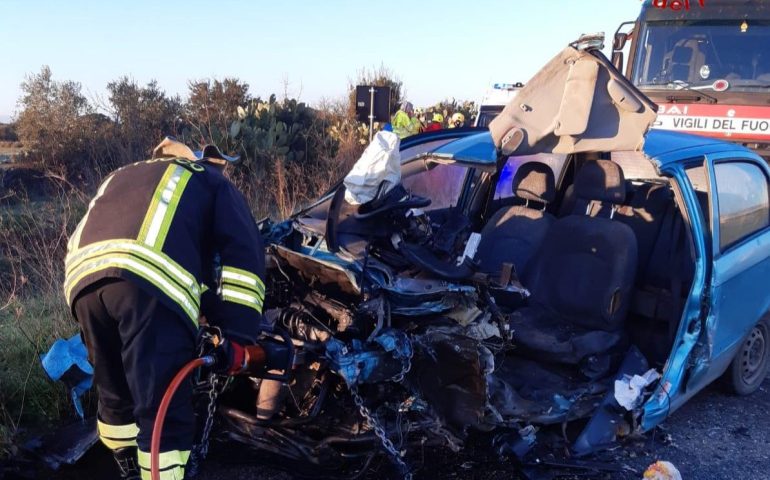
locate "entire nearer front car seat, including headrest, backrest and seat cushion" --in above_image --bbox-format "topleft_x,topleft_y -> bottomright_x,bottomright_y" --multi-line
510,160 -> 637,365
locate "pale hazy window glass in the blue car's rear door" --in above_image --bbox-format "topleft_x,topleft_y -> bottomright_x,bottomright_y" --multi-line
714,162 -> 770,250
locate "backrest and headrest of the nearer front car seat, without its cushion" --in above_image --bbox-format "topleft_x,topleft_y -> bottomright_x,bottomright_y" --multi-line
525,160 -> 637,331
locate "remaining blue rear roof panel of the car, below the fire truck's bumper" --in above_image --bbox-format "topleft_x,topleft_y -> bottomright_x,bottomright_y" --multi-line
643,129 -> 754,167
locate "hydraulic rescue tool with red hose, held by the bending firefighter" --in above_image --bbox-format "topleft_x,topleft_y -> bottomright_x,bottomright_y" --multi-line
150,326 -> 295,480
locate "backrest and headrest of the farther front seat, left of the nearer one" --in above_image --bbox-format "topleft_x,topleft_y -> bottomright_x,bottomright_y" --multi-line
476,162 -> 556,278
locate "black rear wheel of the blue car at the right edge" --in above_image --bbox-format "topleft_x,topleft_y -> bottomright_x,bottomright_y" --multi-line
725,317 -> 770,395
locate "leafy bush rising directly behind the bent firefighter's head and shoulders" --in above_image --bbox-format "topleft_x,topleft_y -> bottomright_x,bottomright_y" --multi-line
107,76 -> 182,163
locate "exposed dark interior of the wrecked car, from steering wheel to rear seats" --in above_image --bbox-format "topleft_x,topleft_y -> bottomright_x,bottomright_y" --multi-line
292,152 -> 695,423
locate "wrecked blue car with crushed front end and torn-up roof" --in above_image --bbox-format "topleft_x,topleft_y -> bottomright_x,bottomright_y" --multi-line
212,38 -> 770,475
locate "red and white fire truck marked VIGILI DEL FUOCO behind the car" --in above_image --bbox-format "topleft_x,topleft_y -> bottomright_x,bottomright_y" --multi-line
612,0 -> 770,160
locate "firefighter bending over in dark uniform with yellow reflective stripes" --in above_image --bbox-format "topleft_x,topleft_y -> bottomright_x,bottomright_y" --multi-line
64,138 -> 265,480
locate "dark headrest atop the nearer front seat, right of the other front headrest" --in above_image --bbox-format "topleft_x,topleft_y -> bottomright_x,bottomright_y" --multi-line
575,160 -> 626,204
